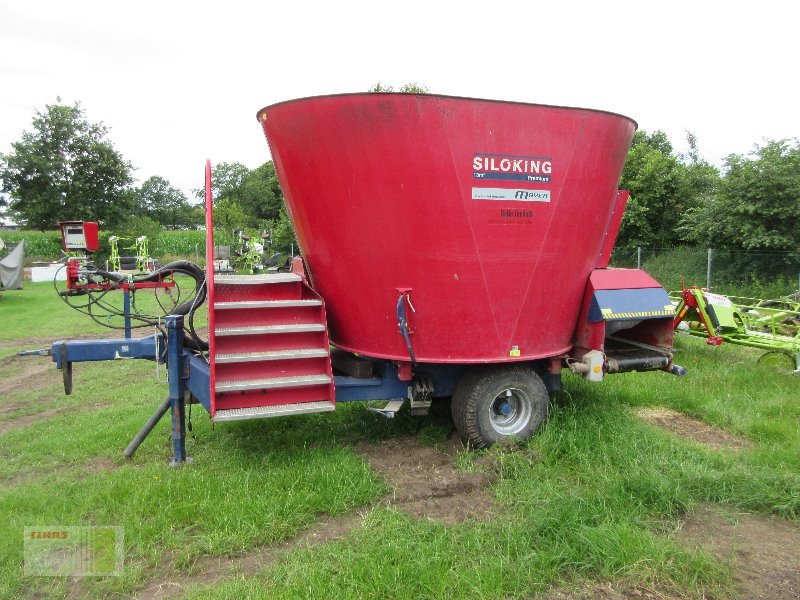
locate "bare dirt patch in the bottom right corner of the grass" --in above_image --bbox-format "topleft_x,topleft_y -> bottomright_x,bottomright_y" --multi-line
676,505 -> 800,600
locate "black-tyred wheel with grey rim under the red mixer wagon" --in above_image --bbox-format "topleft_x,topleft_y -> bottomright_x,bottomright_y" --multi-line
451,366 -> 549,448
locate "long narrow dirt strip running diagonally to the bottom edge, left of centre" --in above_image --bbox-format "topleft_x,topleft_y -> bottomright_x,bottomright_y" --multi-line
138,513 -> 362,600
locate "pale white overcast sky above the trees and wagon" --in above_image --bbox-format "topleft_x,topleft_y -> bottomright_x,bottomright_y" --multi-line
0,0 -> 800,198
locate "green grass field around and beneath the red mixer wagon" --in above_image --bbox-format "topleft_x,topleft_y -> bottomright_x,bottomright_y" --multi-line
0,283 -> 800,598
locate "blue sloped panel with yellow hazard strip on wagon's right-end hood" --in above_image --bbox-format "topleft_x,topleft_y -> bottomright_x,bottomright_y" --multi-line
589,288 -> 675,323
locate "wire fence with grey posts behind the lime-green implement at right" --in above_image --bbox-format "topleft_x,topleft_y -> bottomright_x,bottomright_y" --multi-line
611,248 -> 800,298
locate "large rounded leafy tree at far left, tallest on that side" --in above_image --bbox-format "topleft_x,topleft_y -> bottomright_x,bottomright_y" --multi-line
0,98 -> 131,230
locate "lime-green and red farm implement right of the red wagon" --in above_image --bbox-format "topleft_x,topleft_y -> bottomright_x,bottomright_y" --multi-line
670,287 -> 800,373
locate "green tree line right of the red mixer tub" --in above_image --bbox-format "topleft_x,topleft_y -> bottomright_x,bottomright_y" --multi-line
617,131 -> 800,252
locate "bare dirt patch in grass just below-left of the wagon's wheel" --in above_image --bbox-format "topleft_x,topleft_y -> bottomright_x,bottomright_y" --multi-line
357,438 -> 495,524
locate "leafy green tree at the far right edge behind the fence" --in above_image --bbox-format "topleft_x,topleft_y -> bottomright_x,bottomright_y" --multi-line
685,139 -> 800,251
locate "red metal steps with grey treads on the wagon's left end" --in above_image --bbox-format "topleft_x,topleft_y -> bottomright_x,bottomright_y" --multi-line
209,273 -> 335,422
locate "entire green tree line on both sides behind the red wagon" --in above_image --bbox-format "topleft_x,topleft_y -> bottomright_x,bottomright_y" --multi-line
0,98 -> 800,251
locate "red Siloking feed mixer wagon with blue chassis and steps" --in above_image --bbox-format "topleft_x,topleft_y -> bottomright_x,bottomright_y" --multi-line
28,94 -> 683,462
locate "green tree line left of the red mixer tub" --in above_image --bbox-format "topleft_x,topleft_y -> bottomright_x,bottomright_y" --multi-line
0,99 -> 288,244
